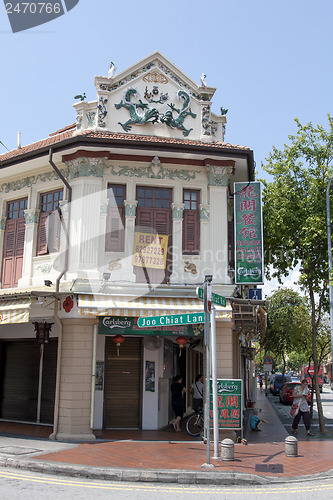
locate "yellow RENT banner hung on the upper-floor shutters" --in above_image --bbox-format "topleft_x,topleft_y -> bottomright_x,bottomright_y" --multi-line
132,233 -> 168,269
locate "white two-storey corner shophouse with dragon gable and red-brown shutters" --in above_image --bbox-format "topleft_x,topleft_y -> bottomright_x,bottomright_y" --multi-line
0,52 -> 264,440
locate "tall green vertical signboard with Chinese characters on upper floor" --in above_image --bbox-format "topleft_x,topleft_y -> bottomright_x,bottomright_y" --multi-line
234,182 -> 264,285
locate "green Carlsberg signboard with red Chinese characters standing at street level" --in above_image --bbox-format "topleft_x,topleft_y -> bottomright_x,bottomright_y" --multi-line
210,379 -> 243,430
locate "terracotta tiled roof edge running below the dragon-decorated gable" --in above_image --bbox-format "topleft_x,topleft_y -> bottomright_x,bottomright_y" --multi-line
0,124 -> 250,162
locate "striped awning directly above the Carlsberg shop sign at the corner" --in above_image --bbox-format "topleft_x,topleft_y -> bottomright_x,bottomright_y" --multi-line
78,295 -> 232,319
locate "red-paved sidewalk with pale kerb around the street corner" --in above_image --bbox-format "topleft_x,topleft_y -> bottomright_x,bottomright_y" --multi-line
0,392 -> 333,484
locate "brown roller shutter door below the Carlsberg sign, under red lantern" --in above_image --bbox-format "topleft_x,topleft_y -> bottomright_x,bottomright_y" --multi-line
104,337 -> 142,429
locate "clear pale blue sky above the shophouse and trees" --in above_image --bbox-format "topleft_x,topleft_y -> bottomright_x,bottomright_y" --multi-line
0,0 -> 333,296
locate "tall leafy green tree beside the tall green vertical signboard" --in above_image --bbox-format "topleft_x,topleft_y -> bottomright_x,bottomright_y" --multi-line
263,115 -> 333,431
